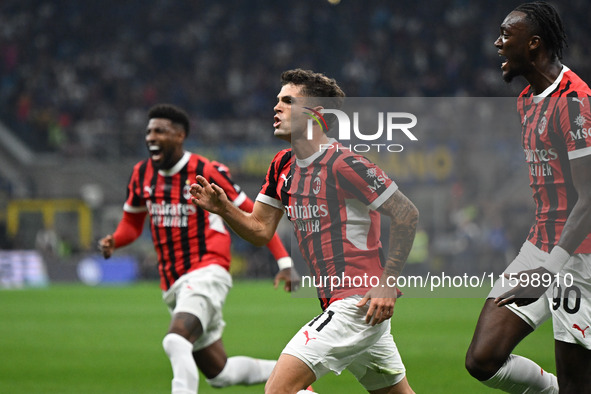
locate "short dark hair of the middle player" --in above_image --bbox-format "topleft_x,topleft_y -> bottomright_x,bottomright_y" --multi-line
281,68 -> 345,127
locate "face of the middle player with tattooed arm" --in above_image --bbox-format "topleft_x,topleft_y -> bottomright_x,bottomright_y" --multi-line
273,83 -> 305,141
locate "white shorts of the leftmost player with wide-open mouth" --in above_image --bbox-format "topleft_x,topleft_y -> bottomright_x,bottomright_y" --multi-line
162,264 -> 232,351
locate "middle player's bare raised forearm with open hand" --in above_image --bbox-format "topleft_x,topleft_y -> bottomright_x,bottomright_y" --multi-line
191,175 -> 283,246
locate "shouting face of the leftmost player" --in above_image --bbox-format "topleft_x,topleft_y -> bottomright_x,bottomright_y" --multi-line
146,118 -> 185,169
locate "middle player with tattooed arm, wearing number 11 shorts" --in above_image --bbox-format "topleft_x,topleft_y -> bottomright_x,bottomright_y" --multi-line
191,69 -> 418,393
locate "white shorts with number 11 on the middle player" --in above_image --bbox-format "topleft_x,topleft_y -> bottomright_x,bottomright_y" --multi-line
282,296 -> 406,391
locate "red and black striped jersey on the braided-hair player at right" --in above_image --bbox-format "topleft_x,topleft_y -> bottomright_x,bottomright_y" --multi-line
517,66 -> 591,253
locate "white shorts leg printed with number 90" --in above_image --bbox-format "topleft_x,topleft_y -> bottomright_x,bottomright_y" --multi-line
552,254 -> 591,350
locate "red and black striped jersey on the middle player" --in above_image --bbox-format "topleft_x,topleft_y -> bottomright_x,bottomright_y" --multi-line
257,140 -> 398,308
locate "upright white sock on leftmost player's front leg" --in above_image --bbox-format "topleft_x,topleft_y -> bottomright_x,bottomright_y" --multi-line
162,334 -> 199,394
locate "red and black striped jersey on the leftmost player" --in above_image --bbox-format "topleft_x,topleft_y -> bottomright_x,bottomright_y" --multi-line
123,152 -> 246,290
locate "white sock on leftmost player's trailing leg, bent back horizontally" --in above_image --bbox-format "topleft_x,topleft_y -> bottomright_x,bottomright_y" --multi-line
207,356 -> 277,388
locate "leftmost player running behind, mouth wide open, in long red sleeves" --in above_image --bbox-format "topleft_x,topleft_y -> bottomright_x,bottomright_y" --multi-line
99,104 -> 295,394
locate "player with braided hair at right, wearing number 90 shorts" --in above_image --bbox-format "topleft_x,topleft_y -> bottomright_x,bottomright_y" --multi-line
466,2 -> 591,393
